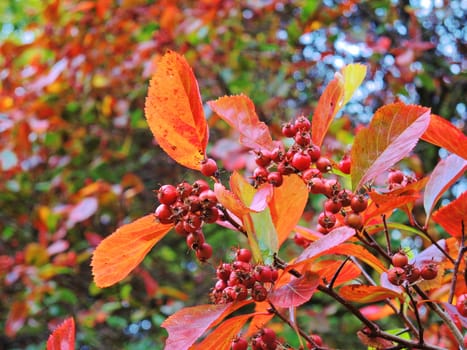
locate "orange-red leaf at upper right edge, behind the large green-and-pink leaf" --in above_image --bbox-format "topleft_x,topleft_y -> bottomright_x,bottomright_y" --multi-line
422,114 -> 467,159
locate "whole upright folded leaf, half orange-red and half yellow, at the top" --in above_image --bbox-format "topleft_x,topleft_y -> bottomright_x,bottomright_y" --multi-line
311,64 -> 366,146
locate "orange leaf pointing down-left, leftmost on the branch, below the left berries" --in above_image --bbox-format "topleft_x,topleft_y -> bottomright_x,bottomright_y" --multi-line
91,214 -> 173,288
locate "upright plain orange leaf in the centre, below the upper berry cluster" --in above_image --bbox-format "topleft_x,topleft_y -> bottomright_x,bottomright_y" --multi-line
269,174 -> 308,247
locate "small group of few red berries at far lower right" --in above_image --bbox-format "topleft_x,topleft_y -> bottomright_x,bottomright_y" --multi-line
387,250 -> 438,286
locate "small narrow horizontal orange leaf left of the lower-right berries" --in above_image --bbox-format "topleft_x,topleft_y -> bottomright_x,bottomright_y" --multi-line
339,284 -> 402,303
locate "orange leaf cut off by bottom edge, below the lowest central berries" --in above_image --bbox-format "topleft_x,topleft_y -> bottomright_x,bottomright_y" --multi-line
193,314 -> 255,350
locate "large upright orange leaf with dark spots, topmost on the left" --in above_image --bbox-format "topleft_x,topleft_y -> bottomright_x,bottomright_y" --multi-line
145,51 -> 208,170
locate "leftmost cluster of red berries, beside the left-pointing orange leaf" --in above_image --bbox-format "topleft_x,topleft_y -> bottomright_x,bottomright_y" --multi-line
155,180 -> 220,261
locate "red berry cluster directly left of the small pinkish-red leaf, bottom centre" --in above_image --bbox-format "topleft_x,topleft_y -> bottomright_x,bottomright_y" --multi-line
210,248 -> 278,304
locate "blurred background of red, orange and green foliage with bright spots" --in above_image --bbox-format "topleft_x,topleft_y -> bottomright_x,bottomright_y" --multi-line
0,0 -> 467,350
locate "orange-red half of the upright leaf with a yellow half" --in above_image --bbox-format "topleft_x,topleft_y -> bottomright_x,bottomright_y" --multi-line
311,74 -> 344,146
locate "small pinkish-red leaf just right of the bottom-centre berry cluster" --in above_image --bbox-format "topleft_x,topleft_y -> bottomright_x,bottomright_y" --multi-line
269,271 -> 320,307
